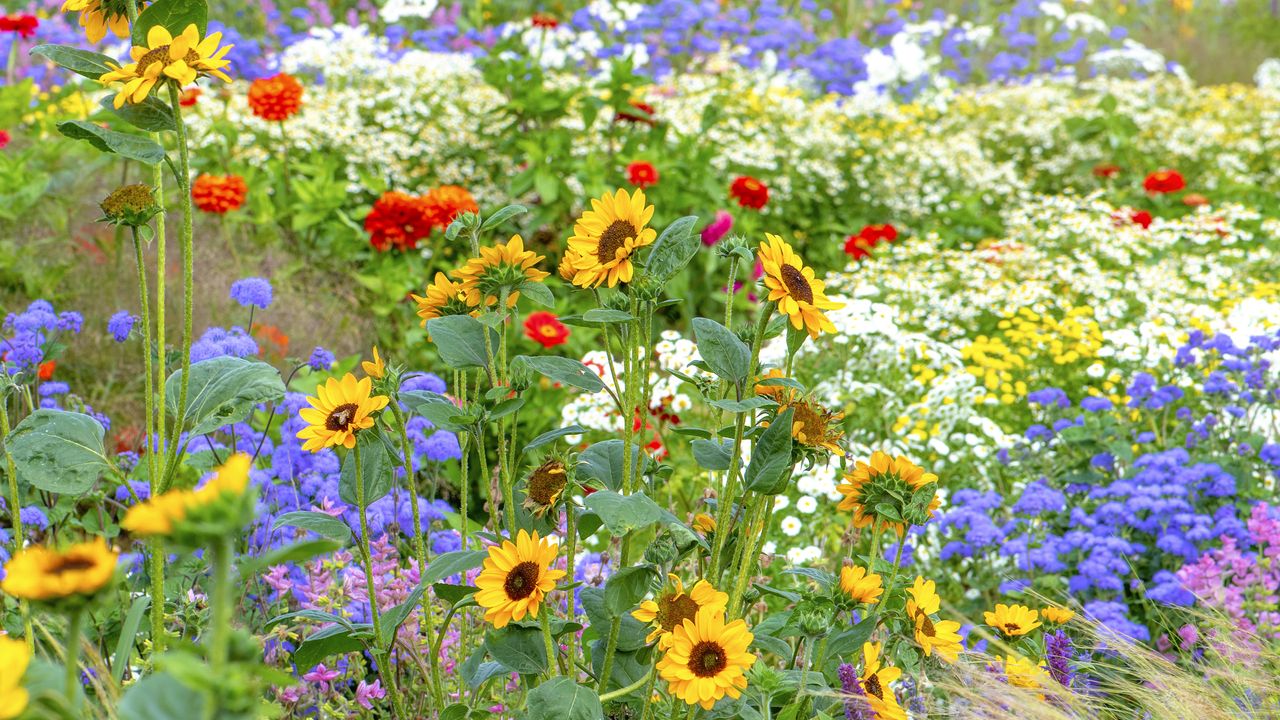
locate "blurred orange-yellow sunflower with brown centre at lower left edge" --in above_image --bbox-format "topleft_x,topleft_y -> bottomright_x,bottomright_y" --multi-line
0,538 -> 118,601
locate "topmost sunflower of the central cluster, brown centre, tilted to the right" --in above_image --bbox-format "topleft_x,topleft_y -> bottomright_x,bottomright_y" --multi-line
562,188 -> 658,287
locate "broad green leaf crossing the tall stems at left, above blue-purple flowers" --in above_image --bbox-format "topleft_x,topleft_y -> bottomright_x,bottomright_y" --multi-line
164,357 -> 284,436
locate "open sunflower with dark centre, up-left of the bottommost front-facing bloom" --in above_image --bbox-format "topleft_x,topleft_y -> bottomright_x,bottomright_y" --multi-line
475,530 -> 564,629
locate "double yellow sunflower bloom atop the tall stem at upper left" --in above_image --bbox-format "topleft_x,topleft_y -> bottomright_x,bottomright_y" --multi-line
99,23 -> 232,108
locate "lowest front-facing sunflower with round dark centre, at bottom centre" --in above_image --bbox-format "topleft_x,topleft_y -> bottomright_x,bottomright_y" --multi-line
658,607 -> 755,710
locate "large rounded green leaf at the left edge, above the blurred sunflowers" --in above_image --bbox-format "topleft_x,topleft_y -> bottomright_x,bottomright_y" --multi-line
6,410 -> 111,495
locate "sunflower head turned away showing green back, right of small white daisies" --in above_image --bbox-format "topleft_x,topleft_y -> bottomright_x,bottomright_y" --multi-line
836,451 -> 942,537
